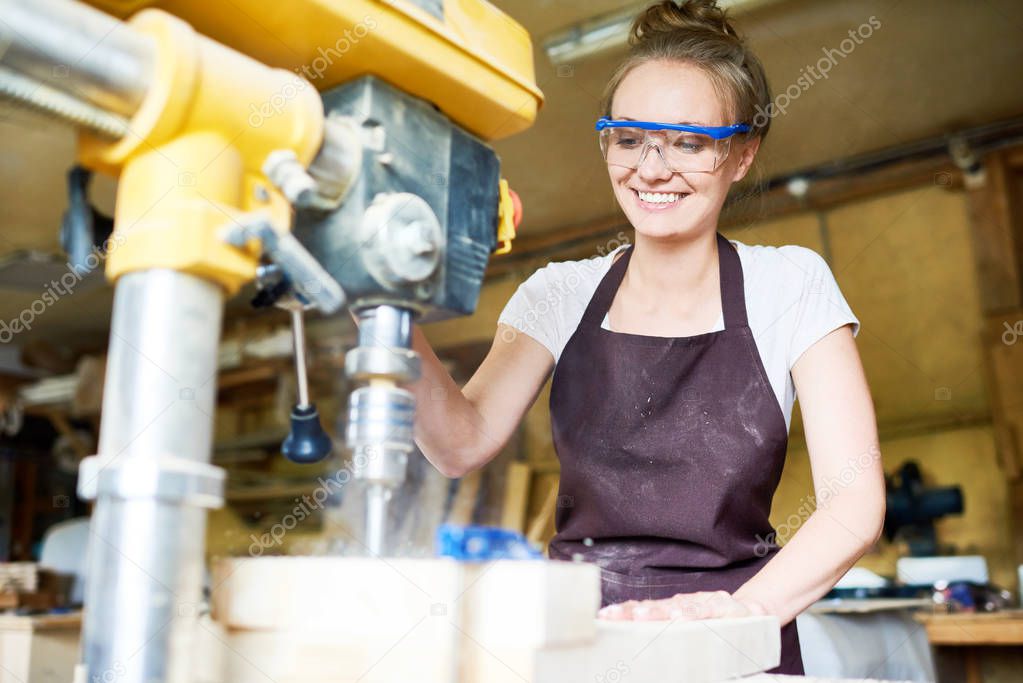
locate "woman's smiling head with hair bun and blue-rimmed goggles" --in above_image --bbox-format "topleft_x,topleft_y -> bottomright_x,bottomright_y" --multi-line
597,2 -> 771,240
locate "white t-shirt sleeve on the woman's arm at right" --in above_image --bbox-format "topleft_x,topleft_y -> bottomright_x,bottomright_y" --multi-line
788,247 -> 859,370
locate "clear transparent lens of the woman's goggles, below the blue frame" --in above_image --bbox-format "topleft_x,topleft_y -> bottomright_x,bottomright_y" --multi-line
599,127 -> 731,173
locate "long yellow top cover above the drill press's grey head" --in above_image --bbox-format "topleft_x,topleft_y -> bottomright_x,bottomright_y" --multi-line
89,0 -> 543,140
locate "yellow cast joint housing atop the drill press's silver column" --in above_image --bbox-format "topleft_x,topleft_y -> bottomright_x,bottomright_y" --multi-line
79,9 -> 323,294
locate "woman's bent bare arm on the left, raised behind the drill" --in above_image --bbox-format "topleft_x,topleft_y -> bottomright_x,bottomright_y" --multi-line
408,324 -> 554,477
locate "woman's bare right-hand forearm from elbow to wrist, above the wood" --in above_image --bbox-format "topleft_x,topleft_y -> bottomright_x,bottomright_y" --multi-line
733,490 -> 884,625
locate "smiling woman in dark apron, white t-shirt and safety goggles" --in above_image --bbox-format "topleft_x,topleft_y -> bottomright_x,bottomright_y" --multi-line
403,0 -> 884,674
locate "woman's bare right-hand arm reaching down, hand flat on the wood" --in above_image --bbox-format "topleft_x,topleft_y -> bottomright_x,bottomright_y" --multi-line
602,325 -> 885,624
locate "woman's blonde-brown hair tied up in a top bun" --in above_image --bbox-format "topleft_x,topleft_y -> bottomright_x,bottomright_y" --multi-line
601,0 -> 771,139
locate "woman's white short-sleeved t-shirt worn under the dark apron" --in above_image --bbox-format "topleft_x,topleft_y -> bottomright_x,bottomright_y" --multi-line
497,239 -> 859,427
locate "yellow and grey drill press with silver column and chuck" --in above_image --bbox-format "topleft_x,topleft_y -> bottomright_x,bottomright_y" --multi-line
0,0 -> 542,683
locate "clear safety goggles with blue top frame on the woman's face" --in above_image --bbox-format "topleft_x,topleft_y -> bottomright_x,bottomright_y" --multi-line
596,117 -> 750,173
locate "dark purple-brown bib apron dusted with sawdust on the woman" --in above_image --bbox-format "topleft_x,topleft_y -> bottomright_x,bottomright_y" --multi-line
549,234 -> 803,674
